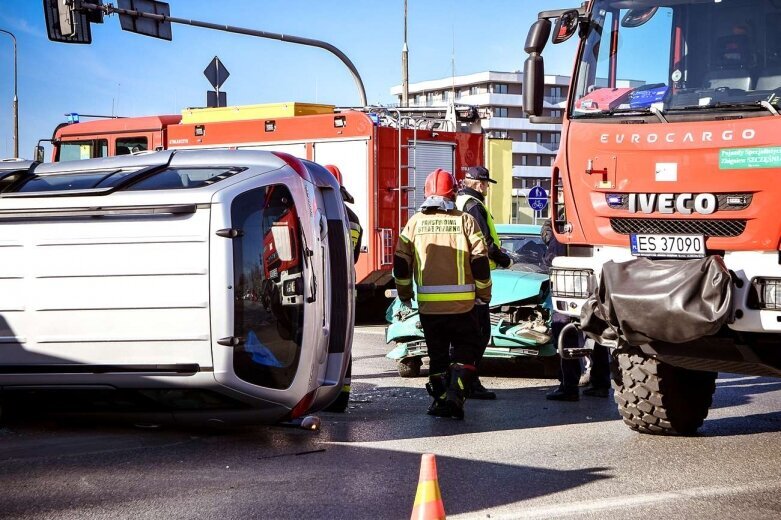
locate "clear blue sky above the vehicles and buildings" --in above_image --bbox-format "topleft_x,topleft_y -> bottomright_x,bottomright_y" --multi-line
0,0 -> 578,158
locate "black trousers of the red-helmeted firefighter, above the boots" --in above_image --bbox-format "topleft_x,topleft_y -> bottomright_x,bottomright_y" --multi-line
420,310 -> 485,375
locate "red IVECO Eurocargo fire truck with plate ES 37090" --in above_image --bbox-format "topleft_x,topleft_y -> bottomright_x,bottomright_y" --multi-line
524,0 -> 781,434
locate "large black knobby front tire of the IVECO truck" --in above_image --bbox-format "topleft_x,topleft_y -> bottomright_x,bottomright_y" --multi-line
613,348 -> 716,435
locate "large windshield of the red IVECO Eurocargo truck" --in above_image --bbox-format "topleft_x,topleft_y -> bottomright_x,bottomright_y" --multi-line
569,0 -> 781,118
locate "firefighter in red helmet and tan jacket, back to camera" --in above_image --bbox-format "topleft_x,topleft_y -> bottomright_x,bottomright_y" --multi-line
393,169 -> 491,419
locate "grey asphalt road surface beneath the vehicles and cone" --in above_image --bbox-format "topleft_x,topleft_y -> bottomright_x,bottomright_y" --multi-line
0,327 -> 781,520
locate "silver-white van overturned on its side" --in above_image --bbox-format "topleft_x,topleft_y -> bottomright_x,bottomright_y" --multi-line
0,150 -> 355,422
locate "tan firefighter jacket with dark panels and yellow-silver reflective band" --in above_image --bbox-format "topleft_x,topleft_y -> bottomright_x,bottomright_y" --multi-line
393,210 -> 491,314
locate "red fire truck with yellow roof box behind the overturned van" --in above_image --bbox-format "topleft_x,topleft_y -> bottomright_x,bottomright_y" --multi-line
47,103 -> 484,294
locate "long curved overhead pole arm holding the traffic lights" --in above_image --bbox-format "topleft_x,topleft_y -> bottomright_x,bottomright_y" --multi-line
81,2 -> 368,106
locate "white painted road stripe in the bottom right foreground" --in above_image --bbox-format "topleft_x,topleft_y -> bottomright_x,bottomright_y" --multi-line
482,482 -> 781,519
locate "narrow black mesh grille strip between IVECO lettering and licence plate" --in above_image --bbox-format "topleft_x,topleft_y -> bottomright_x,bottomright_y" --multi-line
610,218 -> 746,237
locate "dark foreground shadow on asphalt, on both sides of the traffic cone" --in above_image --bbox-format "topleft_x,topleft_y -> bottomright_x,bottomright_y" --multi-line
0,418 -> 609,519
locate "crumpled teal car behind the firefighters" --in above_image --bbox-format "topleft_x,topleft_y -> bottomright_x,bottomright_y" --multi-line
385,224 -> 556,377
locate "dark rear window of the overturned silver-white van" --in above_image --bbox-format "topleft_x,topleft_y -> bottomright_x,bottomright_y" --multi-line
231,185 -> 304,389
